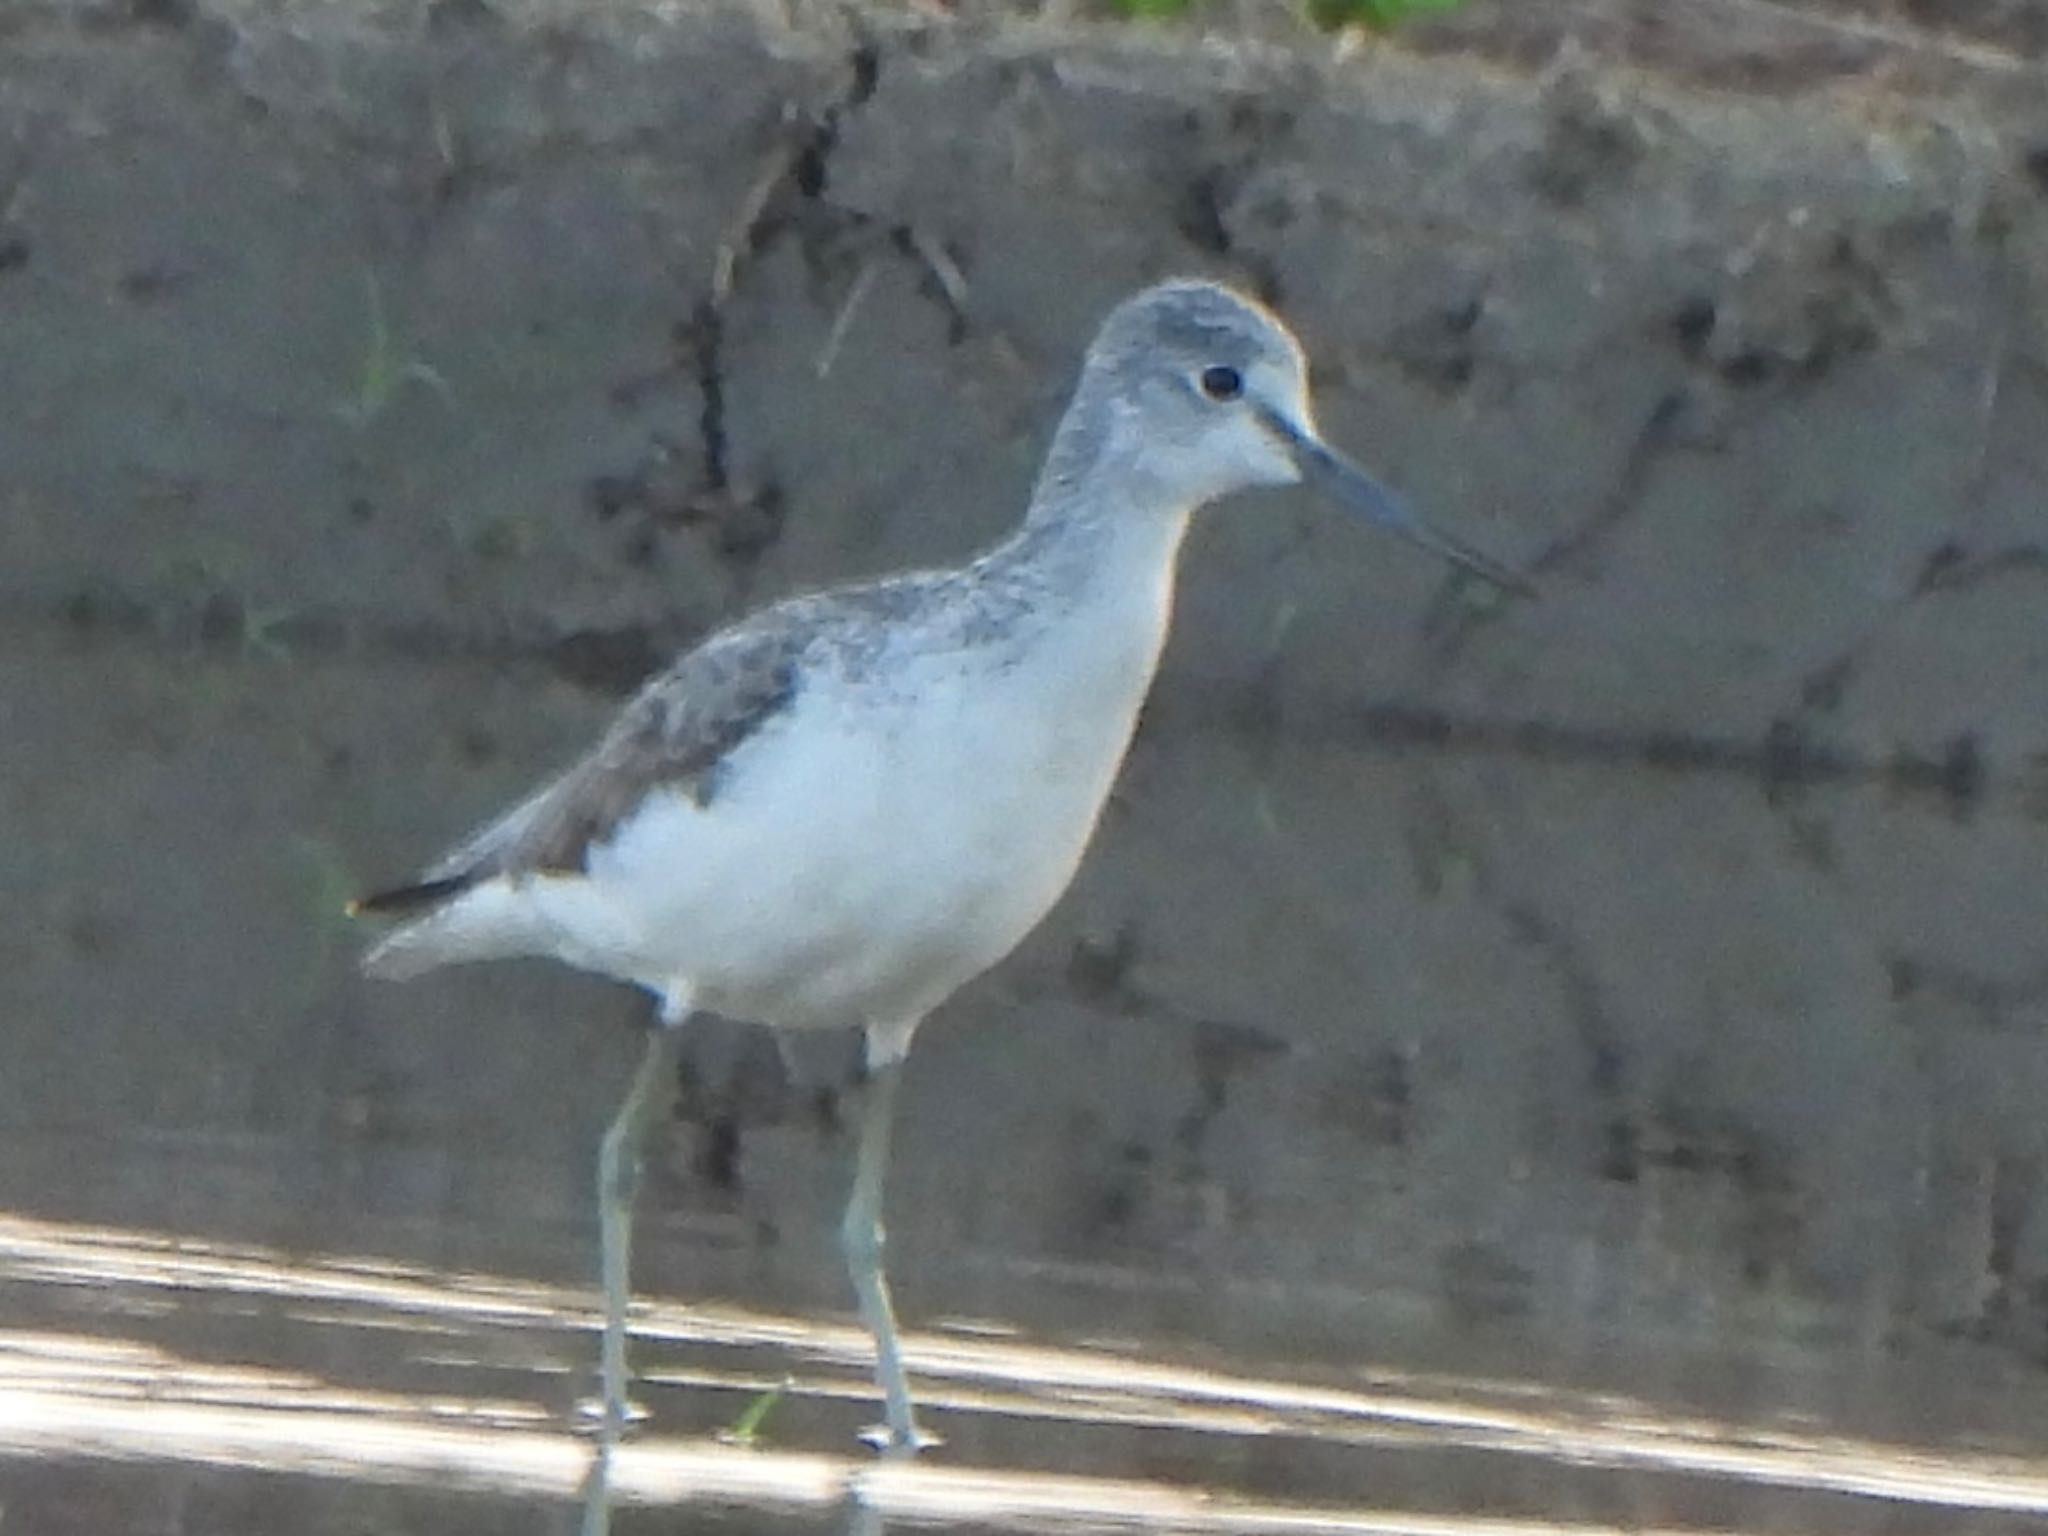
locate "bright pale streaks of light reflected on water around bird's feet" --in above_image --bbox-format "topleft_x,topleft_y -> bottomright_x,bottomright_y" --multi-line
0,1217 -> 2048,1532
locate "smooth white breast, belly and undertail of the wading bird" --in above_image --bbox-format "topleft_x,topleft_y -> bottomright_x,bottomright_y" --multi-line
373,510 -> 1186,1044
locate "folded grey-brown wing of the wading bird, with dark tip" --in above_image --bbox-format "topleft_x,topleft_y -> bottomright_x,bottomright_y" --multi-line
352,625 -> 809,913
